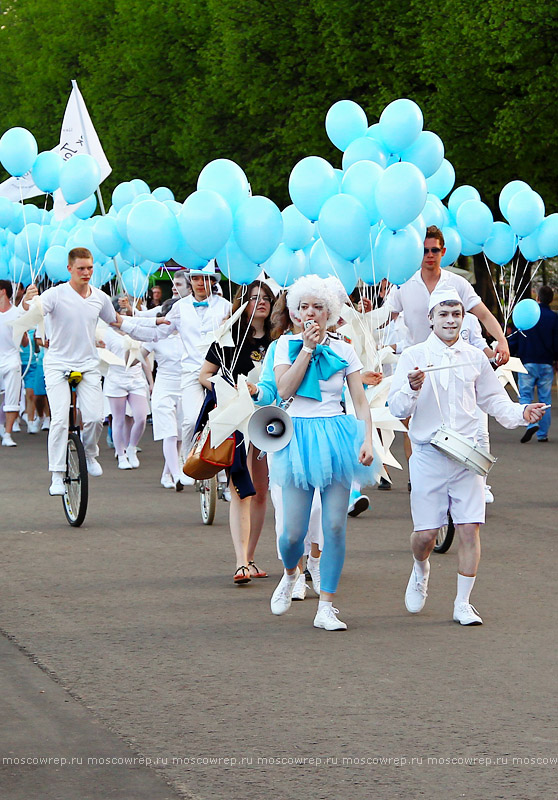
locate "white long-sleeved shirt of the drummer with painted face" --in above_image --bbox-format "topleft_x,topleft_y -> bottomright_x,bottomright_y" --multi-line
388,333 -> 527,444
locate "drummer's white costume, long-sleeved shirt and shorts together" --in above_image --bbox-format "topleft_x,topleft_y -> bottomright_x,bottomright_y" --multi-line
388,333 -> 526,531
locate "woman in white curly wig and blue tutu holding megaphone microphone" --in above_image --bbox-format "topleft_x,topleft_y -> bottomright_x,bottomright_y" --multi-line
271,275 -> 375,631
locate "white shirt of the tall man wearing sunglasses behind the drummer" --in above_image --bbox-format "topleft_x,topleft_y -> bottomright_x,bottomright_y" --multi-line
387,269 -> 482,345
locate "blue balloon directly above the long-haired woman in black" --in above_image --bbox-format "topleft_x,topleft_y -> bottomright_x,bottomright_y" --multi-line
234,195 -> 283,264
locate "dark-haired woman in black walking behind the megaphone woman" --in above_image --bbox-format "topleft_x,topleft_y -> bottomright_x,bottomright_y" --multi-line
199,281 -> 275,585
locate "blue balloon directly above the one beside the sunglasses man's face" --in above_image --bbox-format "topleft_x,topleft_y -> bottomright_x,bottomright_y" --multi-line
375,162 -> 427,231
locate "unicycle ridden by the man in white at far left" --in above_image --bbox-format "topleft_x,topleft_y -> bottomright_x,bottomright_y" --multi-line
62,371 -> 89,528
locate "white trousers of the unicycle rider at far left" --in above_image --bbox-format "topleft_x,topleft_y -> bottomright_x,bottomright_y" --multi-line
45,367 -> 103,472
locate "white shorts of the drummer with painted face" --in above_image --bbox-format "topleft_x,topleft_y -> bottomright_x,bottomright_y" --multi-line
409,443 -> 486,531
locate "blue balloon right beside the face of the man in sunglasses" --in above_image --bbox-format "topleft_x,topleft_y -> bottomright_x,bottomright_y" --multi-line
373,225 -> 424,286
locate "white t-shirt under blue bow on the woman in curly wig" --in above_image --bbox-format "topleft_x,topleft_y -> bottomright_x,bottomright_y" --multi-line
273,334 -> 362,417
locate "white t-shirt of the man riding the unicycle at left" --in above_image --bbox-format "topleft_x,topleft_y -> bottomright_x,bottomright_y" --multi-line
41,283 -> 116,371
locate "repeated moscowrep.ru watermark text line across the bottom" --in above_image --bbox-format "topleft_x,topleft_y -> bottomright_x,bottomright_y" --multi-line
0,754 -> 558,769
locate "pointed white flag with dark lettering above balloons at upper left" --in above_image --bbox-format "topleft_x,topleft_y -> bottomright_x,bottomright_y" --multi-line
54,81 -> 112,219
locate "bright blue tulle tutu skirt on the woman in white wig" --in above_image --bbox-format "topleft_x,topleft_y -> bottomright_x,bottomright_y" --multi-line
270,414 -> 376,489
